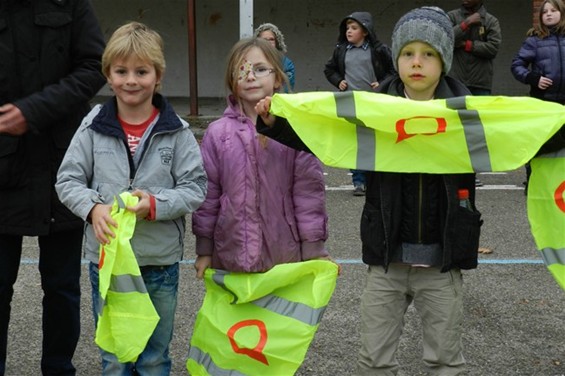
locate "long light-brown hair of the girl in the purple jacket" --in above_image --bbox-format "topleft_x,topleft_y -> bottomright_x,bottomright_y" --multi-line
224,38 -> 288,102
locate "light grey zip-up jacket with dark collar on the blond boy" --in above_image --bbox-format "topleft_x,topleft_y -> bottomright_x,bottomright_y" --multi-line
55,95 -> 207,266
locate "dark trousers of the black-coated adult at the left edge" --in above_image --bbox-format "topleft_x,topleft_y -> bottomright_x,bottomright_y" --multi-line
0,227 -> 83,375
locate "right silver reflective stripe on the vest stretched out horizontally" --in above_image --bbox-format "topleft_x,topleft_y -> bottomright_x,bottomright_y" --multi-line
446,97 -> 492,172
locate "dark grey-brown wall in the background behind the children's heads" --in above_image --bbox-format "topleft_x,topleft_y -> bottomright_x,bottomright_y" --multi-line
92,0 -> 532,97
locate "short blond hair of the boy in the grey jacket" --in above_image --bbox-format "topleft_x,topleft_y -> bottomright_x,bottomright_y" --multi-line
102,21 -> 166,91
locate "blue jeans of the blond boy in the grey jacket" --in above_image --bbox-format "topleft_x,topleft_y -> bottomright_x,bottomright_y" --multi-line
89,263 -> 179,376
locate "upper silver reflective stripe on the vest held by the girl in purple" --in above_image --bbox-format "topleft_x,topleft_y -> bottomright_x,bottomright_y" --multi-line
212,270 -> 326,326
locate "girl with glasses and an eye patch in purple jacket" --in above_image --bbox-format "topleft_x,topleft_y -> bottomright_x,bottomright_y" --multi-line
192,38 -> 329,278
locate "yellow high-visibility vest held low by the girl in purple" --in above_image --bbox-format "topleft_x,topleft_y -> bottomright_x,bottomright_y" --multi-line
186,260 -> 338,376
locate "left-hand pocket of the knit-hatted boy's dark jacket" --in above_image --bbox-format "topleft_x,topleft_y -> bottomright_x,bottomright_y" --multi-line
361,202 -> 386,258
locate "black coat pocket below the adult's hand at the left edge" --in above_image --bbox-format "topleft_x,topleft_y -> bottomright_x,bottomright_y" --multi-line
0,135 -> 26,189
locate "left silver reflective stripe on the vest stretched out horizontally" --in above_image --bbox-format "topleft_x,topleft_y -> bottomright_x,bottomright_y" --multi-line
334,91 -> 377,171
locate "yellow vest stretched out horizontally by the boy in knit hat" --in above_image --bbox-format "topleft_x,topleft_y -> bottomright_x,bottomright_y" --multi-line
271,91 -> 565,173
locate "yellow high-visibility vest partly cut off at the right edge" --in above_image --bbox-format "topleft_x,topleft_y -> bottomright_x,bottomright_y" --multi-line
528,149 -> 565,290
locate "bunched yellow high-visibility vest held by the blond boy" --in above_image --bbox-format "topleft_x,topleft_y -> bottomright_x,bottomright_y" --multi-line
95,192 -> 159,363
